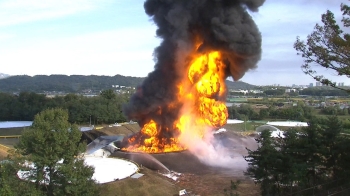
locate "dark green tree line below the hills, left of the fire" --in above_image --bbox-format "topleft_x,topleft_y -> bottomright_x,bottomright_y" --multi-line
0,89 -> 130,124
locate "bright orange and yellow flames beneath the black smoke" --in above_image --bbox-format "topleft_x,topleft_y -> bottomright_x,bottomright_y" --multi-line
122,51 -> 228,153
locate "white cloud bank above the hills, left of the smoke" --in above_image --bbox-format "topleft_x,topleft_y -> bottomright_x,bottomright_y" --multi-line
0,26 -> 159,77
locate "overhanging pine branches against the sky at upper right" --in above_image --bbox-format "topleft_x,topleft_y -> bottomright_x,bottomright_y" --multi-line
294,4 -> 350,92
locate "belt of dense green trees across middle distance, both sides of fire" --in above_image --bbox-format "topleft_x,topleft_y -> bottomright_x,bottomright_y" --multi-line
0,89 -> 350,129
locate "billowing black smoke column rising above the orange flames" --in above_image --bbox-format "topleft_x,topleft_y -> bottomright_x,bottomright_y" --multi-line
124,0 -> 265,137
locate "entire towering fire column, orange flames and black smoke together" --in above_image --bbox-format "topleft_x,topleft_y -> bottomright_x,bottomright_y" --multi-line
123,0 -> 264,153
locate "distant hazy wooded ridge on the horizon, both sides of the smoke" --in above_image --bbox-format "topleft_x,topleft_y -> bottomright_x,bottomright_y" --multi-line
0,75 -> 255,93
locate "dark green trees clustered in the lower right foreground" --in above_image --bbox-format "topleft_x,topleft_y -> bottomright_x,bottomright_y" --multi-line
245,116 -> 350,195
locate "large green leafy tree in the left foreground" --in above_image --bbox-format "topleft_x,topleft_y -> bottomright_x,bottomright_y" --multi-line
10,109 -> 98,195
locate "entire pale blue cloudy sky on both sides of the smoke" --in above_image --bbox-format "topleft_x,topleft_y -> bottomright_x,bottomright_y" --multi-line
0,0 -> 350,85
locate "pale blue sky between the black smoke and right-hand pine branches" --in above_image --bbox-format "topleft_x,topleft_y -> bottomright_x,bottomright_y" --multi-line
242,0 -> 350,85
